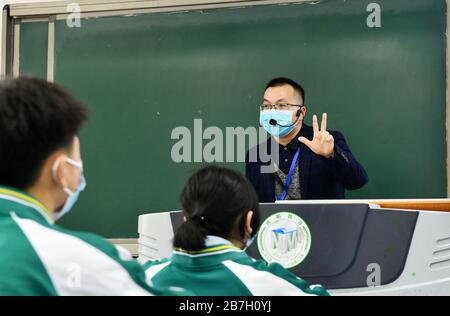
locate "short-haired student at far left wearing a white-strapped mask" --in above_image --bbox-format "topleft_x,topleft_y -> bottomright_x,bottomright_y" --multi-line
0,78 -> 183,296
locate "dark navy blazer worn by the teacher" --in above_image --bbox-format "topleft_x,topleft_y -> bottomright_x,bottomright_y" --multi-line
245,124 -> 368,203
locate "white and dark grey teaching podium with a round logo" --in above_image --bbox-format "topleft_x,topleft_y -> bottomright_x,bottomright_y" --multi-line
139,200 -> 450,295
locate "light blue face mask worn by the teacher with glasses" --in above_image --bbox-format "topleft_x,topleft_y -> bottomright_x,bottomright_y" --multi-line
259,110 -> 295,137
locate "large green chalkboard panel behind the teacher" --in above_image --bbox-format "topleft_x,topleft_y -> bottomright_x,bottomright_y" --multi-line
18,0 -> 446,237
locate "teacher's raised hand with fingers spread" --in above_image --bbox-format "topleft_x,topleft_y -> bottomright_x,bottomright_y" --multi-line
298,113 -> 334,158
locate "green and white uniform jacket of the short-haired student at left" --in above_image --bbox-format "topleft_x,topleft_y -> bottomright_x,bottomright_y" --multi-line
0,187 -> 182,296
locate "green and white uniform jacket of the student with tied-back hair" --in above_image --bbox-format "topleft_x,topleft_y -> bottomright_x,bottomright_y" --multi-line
144,236 -> 328,296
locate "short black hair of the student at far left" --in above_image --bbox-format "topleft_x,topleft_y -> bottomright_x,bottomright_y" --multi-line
0,77 -> 89,189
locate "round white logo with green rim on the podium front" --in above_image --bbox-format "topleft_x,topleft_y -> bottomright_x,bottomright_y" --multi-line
258,212 -> 311,269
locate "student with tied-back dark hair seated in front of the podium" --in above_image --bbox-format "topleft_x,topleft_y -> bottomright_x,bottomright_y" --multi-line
145,166 -> 328,296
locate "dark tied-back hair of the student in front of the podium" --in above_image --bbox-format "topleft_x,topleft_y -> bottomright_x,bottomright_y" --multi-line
174,165 -> 260,251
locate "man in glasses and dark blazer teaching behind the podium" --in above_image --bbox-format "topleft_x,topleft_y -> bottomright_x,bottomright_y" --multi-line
246,78 -> 368,203
